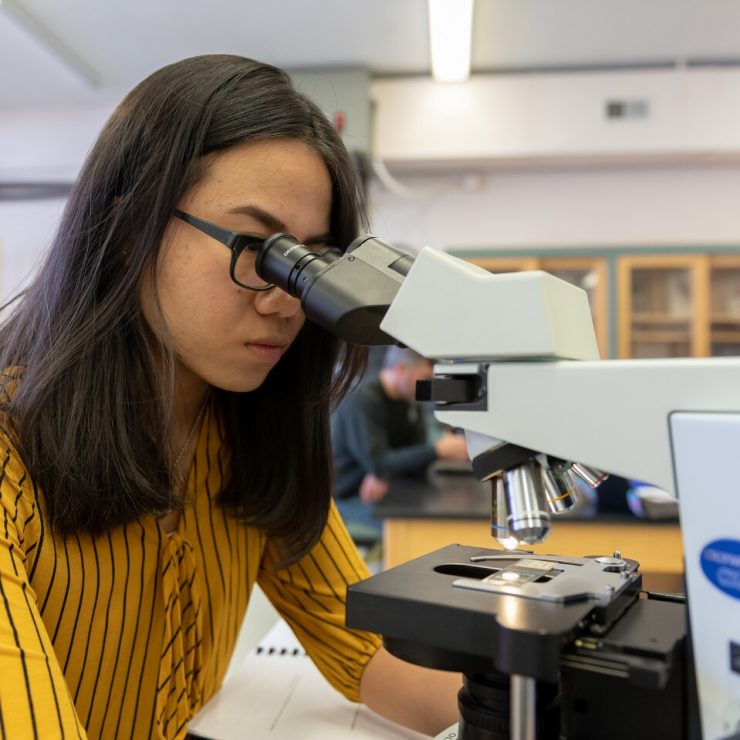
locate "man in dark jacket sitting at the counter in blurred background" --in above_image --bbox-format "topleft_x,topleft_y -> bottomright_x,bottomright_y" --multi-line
331,347 -> 468,532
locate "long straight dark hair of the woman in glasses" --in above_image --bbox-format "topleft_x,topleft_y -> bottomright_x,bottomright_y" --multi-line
0,55 -> 365,562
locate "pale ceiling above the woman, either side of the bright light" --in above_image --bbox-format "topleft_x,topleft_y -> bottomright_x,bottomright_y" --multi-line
0,0 -> 740,109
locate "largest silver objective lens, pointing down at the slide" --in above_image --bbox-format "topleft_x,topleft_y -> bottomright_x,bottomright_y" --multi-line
504,460 -> 550,545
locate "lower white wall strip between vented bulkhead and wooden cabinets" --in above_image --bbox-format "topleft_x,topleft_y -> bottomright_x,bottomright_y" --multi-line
372,165 -> 740,251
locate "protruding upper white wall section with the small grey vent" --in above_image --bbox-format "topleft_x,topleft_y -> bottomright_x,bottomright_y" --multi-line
370,68 -> 740,166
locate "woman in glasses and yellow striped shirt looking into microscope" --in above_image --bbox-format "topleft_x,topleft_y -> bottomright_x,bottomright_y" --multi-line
0,56 -> 459,738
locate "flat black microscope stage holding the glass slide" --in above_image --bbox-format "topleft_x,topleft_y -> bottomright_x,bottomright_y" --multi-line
347,545 -> 642,681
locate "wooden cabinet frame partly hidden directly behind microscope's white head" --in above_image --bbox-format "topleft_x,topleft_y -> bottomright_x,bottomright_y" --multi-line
468,256 -> 609,357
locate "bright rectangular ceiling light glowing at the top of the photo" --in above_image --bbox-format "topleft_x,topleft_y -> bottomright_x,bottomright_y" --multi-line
429,0 -> 473,82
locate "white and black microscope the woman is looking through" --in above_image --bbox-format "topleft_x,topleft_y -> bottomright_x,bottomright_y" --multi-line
257,234 -> 740,740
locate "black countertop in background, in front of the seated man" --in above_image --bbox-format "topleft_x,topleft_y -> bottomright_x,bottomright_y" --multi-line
373,473 -> 678,526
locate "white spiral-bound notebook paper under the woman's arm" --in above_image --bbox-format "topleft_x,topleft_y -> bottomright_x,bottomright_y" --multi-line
189,620 -> 426,740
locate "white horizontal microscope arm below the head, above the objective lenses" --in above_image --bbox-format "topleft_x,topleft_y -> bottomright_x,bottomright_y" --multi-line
435,358 -> 740,496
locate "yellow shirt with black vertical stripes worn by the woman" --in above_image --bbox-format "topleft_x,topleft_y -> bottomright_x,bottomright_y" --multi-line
0,406 -> 380,740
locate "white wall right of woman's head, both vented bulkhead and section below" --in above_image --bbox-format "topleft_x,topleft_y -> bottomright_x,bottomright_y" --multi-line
371,68 -> 740,249
